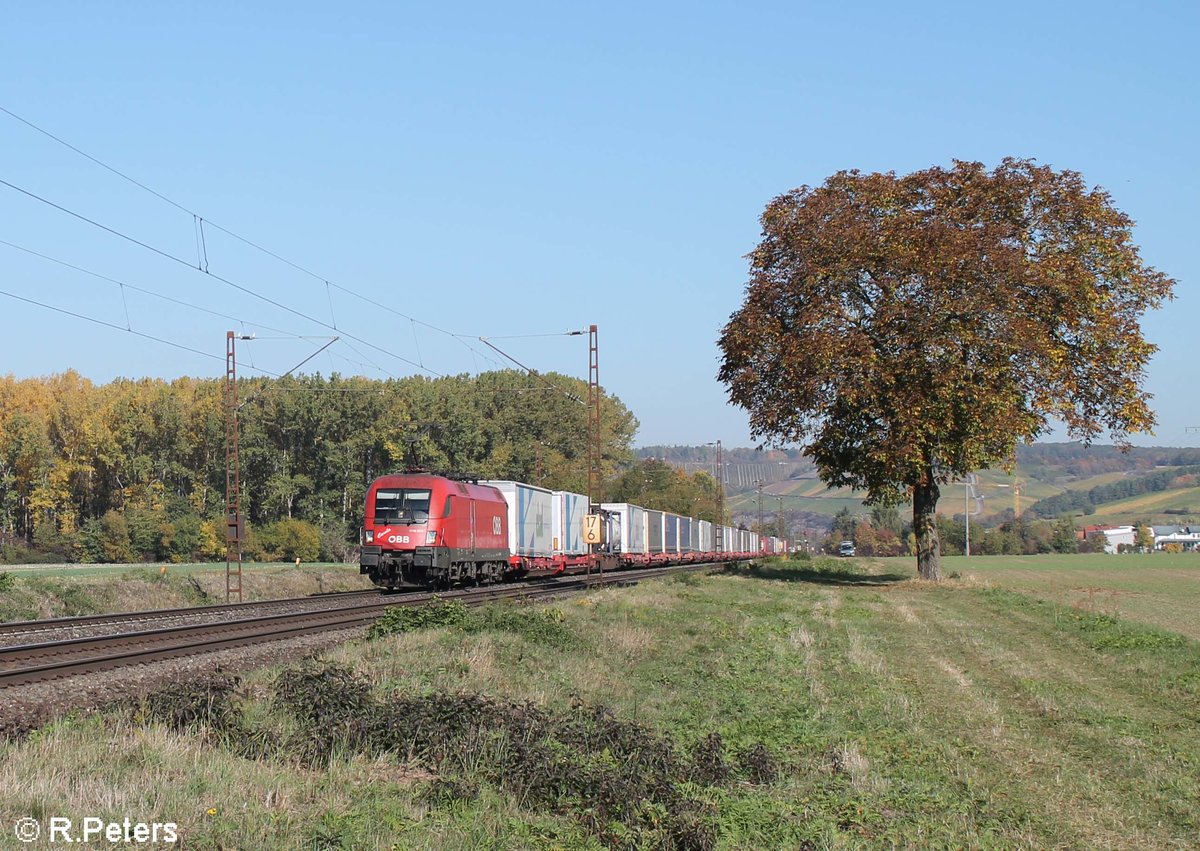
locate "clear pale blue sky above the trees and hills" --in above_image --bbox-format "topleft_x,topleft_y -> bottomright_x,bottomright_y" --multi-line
0,2 -> 1200,445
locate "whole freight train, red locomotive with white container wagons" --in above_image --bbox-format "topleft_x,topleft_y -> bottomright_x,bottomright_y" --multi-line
359,473 -> 786,589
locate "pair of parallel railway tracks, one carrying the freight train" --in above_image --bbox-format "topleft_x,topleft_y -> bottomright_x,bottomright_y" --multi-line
0,564 -> 715,689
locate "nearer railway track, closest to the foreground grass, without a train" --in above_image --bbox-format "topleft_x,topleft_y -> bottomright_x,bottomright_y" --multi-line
0,563 -> 715,689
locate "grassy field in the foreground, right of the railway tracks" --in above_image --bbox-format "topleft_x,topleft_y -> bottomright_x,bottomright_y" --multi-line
0,556 -> 1200,850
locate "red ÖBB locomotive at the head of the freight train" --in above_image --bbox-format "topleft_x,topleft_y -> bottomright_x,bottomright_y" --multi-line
360,473 -> 510,588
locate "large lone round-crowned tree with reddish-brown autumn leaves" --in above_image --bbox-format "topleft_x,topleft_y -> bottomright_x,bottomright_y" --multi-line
720,158 -> 1175,580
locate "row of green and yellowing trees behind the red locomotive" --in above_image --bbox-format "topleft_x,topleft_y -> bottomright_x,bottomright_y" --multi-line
0,371 -> 643,561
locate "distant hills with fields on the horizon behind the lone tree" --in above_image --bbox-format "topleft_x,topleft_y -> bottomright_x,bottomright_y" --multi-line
635,443 -> 1200,528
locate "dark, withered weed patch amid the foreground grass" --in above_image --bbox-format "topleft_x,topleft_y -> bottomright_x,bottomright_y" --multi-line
275,663 -> 778,851
